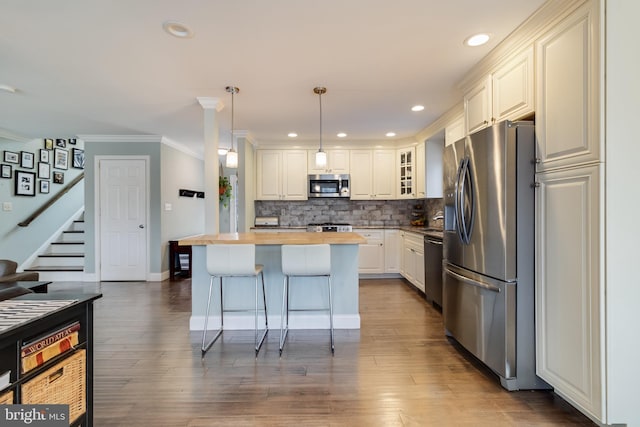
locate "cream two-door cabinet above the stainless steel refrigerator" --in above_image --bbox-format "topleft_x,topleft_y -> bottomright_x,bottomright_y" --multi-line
464,46 -> 534,135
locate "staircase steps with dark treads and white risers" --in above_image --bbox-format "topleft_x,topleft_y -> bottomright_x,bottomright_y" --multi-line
24,213 -> 84,282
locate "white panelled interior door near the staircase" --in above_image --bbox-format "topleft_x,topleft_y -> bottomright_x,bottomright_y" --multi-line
99,159 -> 147,280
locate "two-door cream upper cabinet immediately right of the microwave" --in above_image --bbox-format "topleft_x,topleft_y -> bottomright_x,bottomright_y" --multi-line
349,150 -> 396,200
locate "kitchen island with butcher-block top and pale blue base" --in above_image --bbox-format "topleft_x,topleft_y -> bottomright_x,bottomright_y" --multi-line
178,232 -> 366,331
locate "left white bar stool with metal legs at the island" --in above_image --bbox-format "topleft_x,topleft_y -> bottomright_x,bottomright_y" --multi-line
202,244 -> 269,357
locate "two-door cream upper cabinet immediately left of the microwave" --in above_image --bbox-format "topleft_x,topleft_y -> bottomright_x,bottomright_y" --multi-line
256,150 -> 307,200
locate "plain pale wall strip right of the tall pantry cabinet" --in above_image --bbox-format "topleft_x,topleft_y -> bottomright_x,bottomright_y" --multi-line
605,0 -> 640,426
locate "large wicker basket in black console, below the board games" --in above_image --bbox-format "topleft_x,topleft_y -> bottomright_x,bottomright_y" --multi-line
21,350 -> 87,423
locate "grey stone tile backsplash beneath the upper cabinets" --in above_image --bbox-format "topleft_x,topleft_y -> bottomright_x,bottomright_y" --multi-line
255,199 -> 442,227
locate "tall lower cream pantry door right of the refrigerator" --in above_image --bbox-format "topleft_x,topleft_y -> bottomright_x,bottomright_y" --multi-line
535,166 -> 604,419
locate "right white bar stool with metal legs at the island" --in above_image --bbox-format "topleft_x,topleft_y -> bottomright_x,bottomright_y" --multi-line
280,244 -> 334,356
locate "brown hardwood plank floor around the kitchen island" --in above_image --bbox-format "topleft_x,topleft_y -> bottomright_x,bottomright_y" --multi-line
50,279 -> 595,427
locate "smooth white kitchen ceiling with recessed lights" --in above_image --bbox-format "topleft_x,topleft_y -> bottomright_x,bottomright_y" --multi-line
0,0 -> 543,154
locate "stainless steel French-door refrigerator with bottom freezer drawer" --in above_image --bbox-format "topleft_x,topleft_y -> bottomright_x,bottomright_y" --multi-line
442,121 -> 550,390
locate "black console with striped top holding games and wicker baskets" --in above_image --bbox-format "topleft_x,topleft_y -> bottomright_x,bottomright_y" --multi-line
0,293 -> 102,426
